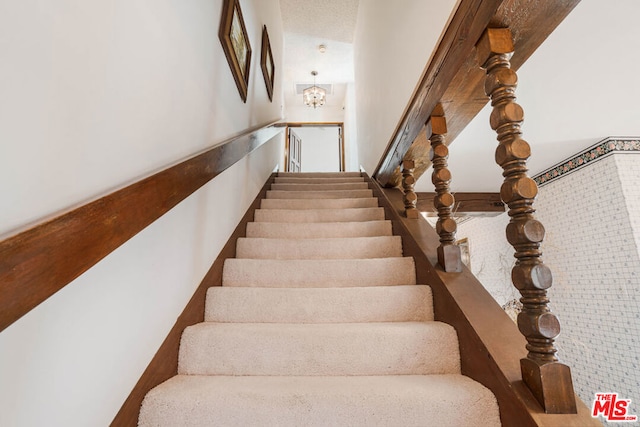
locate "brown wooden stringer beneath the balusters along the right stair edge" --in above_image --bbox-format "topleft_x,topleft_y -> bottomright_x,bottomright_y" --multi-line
369,175 -> 600,427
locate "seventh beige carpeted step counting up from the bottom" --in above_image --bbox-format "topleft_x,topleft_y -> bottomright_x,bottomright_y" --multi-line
253,208 -> 384,223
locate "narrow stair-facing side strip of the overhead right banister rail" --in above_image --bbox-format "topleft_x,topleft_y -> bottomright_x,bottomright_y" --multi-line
373,0 -> 503,186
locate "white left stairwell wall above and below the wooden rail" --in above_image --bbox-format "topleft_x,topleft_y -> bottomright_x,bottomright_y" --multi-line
0,0 -> 283,426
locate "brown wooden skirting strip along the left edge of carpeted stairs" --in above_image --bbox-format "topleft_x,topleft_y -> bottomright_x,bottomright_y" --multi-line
111,174 -> 276,427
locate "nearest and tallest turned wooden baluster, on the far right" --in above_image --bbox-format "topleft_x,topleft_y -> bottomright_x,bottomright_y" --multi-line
476,28 -> 576,414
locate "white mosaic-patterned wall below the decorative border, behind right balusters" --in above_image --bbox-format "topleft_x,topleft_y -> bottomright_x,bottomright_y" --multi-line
458,153 -> 640,422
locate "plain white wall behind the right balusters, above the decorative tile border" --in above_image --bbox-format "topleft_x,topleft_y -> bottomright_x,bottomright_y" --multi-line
416,0 -> 640,191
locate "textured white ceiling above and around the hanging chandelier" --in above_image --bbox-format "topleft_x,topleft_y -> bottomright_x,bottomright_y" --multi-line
280,0 -> 358,113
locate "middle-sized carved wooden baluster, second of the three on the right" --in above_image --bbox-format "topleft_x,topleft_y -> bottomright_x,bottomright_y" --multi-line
427,105 -> 462,272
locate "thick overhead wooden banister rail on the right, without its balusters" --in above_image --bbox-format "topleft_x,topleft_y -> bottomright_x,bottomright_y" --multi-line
373,0 -> 580,187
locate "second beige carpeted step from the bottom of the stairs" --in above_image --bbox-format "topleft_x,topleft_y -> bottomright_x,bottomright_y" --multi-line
178,322 -> 460,375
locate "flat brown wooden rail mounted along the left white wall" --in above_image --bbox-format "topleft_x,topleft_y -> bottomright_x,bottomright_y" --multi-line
0,123 -> 282,332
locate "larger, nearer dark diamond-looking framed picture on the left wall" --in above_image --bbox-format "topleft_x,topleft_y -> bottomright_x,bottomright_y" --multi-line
218,0 -> 251,102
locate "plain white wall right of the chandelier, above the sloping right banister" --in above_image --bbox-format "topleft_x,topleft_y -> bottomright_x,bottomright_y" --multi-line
354,0 -> 456,173
